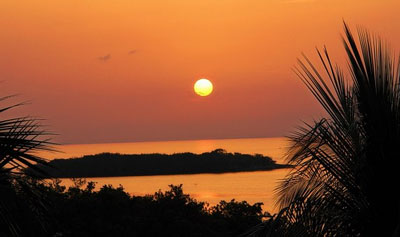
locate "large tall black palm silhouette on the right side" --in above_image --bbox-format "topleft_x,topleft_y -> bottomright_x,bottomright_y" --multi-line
270,23 -> 400,236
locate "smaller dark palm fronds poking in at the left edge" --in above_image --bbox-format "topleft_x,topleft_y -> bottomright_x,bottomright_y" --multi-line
0,96 -> 53,236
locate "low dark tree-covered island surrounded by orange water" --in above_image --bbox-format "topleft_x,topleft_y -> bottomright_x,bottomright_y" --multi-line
33,149 -> 288,178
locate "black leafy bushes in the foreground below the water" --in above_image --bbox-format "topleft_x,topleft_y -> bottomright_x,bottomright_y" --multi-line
0,179 -> 269,236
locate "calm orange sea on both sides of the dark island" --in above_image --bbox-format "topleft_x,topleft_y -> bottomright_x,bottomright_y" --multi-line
42,137 -> 289,212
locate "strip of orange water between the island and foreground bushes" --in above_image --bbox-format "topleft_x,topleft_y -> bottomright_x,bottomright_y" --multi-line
63,169 -> 288,212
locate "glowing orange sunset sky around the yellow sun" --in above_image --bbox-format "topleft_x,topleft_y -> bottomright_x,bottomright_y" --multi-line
0,0 -> 400,143
